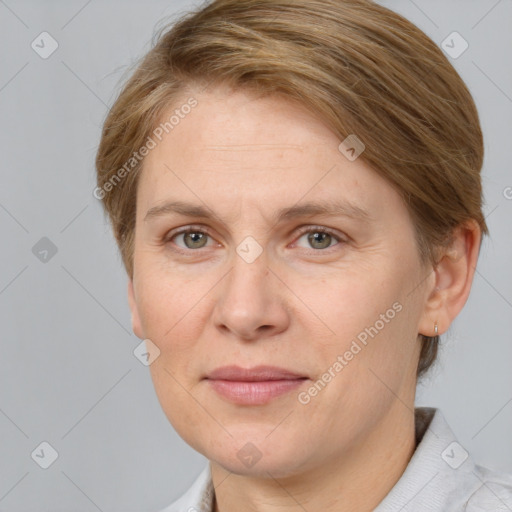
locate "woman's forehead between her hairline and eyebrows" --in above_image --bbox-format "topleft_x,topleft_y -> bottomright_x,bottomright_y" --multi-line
134,89 -> 402,222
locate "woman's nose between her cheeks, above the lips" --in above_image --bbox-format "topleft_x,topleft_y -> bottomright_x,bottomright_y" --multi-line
213,252 -> 290,340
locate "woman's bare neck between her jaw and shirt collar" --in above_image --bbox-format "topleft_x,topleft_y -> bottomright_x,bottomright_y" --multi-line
210,400 -> 416,512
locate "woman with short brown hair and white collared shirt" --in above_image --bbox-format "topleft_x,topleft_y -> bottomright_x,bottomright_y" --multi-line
95,0 -> 512,512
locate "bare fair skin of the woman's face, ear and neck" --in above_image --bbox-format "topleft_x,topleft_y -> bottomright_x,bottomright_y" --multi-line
128,87 -> 480,512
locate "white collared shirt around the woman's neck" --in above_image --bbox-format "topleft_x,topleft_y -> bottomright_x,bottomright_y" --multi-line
160,407 -> 512,512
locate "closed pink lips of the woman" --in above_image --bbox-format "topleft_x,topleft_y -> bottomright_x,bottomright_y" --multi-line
205,366 -> 308,405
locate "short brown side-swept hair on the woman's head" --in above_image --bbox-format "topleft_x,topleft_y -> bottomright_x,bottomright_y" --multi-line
95,0 -> 488,377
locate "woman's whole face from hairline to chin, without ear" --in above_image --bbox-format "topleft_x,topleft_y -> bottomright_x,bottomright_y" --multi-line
129,83 -> 428,476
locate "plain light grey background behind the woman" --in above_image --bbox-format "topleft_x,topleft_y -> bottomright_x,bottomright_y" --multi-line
0,0 -> 512,512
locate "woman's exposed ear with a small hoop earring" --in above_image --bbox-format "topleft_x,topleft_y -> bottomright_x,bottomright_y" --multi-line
418,220 -> 482,336
